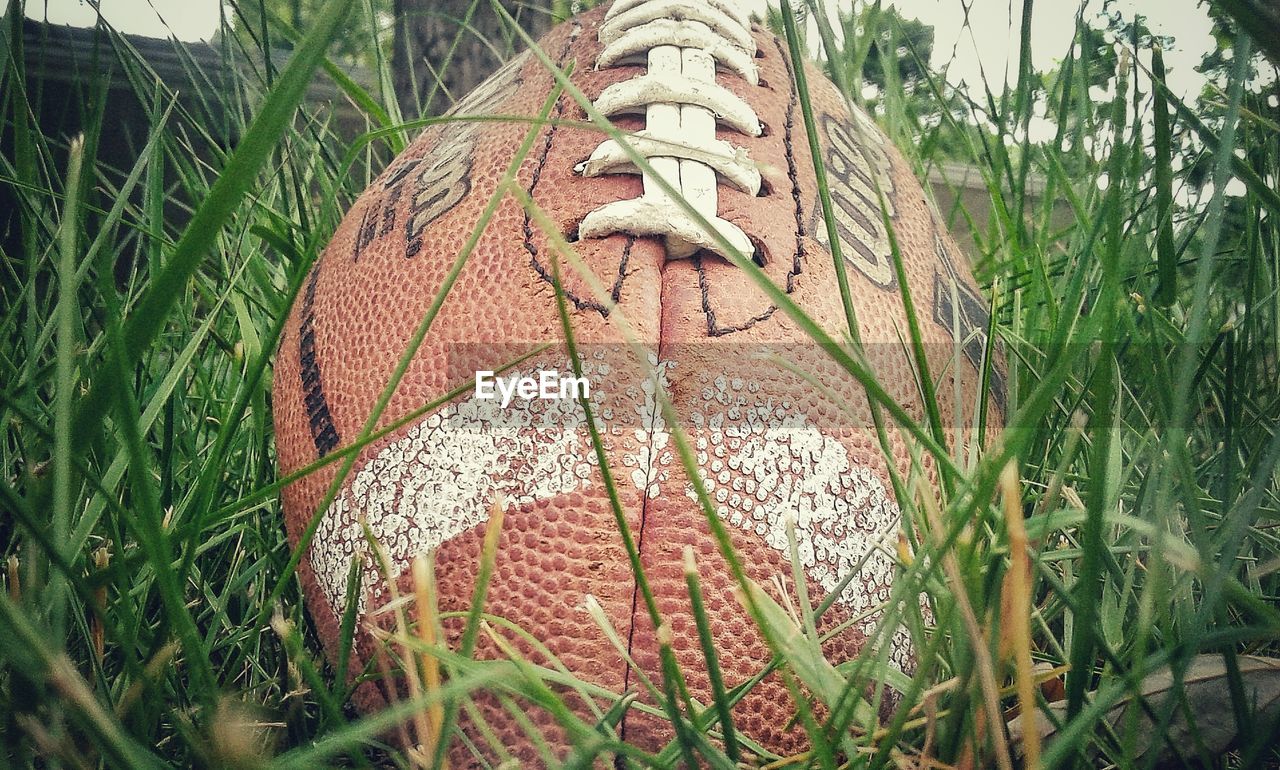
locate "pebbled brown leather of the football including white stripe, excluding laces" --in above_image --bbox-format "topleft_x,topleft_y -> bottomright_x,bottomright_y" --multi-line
274,2 -> 1002,766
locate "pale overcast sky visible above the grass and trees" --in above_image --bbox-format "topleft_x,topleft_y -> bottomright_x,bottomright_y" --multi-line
0,0 -> 1212,96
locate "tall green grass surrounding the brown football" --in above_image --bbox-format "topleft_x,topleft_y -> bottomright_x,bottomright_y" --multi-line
0,0 -> 1280,767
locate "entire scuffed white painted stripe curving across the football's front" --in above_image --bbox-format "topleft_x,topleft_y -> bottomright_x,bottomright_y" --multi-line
310,357 -> 910,666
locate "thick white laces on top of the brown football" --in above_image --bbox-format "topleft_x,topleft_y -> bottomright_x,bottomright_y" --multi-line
575,0 -> 763,258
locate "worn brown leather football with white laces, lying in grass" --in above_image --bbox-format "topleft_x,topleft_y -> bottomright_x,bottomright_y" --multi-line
273,0 -> 1005,766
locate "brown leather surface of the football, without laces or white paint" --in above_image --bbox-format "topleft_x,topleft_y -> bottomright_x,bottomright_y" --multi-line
274,1 -> 998,765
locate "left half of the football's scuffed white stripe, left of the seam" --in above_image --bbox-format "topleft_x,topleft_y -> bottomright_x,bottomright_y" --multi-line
310,362 -> 595,615
